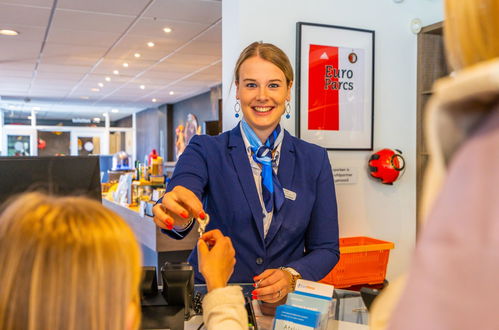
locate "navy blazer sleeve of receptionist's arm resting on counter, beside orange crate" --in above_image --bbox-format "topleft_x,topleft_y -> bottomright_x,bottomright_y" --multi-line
287,149 -> 340,281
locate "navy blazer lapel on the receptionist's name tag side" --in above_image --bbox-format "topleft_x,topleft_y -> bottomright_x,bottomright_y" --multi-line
265,131 -> 295,246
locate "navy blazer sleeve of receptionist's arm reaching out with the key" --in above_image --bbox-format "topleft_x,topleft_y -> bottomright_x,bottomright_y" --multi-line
157,135 -> 208,240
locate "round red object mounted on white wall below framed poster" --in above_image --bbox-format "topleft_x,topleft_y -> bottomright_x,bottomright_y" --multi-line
369,148 -> 405,184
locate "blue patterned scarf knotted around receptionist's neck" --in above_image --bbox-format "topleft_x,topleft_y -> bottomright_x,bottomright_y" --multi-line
241,119 -> 284,212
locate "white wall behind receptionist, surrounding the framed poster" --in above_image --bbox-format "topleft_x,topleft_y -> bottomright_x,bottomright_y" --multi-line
222,0 -> 443,279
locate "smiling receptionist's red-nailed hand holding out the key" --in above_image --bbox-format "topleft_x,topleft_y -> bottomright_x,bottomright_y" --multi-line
152,186 -> 206,230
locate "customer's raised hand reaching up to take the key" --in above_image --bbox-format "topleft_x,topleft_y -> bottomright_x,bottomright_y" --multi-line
198,229 -> 236,291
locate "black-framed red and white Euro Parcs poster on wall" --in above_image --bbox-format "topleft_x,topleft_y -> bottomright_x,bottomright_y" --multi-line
295,22 -> 374,150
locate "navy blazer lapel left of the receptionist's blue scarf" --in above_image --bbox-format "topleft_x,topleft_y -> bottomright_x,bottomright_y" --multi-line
228,124 -> 263,241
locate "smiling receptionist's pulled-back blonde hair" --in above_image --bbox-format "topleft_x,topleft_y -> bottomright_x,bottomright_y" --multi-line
234,41 -> 293,87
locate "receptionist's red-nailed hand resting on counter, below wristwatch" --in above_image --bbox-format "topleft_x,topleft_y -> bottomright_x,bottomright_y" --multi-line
252,269 -> 292,303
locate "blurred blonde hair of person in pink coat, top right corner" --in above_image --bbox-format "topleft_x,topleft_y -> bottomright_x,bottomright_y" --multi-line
444,0 -> 499,69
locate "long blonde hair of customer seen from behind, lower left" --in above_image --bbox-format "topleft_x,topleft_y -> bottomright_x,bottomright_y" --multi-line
0,193 -> 141,330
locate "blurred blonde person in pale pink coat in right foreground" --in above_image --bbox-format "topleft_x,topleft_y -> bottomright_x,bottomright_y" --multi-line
370,0 -> 499,330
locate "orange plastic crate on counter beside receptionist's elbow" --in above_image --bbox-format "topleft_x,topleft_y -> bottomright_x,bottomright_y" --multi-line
320,236 -> 394,288
